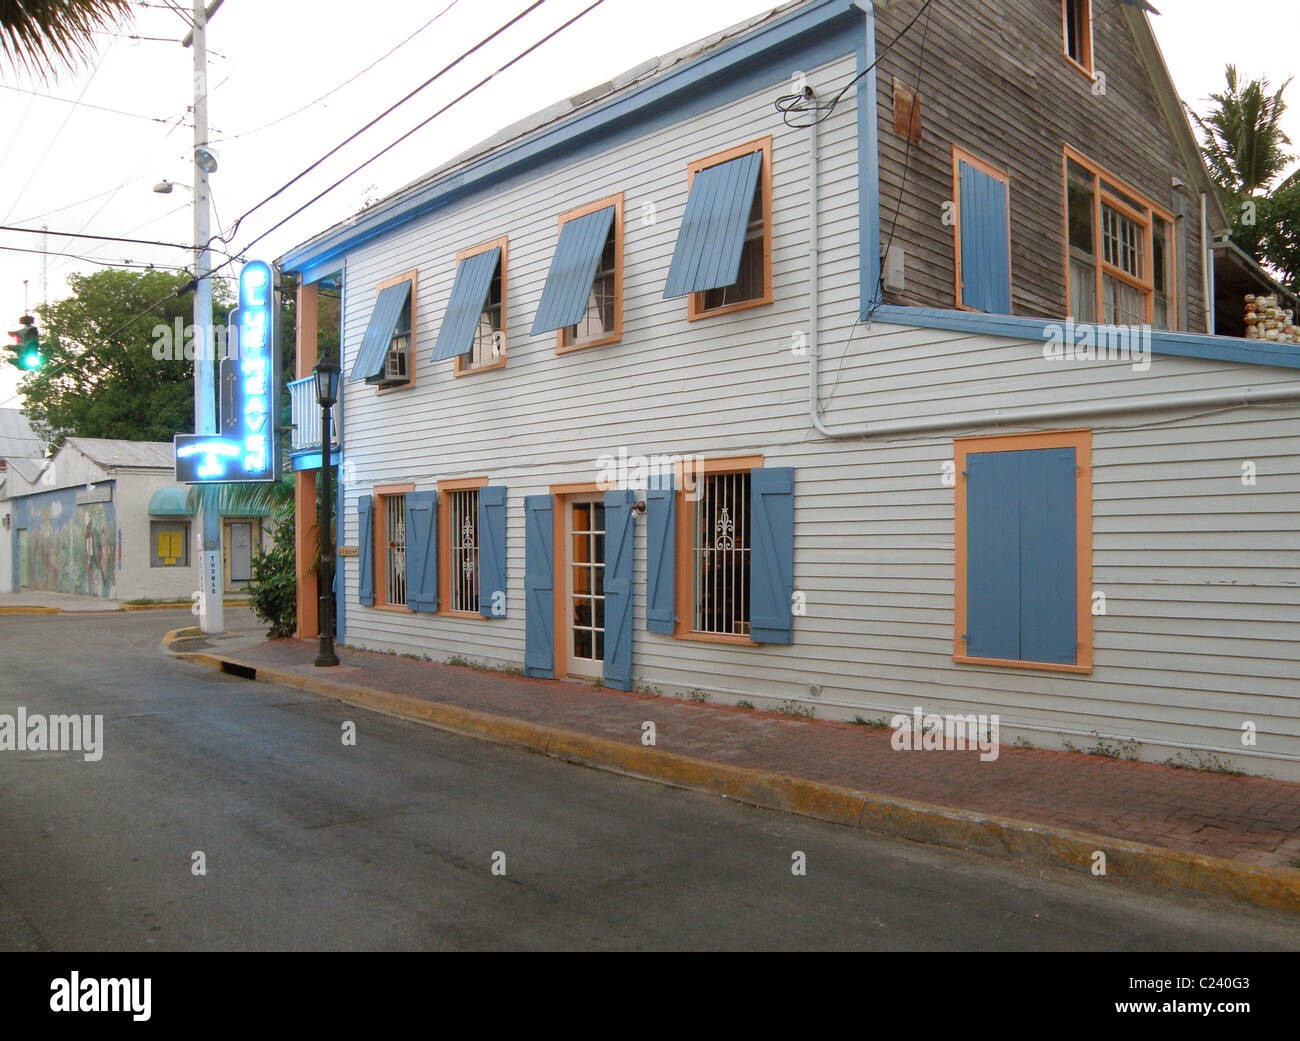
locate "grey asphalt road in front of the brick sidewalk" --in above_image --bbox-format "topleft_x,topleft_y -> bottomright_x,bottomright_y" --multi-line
0,611 -> 1300,951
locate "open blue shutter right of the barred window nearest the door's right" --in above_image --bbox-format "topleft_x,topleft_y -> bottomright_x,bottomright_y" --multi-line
749,467 -> 794,643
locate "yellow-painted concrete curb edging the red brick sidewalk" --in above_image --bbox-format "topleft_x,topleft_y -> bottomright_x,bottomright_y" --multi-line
178,649 -> 1300,911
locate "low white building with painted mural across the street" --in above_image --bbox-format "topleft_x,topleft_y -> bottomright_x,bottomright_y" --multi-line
0,438 -> 264,600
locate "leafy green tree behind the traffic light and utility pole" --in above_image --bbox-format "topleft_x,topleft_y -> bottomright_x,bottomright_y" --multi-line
20,268 -> 234,444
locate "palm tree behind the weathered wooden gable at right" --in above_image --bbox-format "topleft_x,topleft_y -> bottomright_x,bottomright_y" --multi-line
1191,65 -> 1300,289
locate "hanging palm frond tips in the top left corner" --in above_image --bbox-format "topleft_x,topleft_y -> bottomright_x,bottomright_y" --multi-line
0,0 -> 133,77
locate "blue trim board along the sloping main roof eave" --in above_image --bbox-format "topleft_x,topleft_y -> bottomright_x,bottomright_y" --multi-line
281,0 -> 879,273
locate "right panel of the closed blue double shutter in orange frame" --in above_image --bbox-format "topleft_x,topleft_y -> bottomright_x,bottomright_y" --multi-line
1015,448 -> 1079,665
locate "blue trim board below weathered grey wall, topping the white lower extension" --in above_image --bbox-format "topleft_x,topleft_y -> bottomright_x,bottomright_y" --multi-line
862,304 -> 1300,369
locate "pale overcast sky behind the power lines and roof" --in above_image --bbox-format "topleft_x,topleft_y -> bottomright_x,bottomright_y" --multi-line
0,0 -> 1300,407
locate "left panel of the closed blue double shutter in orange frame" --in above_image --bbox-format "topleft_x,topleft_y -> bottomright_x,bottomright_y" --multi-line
965,452 -> 1021,662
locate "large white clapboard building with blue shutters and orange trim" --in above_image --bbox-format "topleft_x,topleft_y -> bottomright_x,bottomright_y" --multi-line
281,0 -> 1300,778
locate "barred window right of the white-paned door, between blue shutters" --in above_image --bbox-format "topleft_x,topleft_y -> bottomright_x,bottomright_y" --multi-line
690,472 -> 750,637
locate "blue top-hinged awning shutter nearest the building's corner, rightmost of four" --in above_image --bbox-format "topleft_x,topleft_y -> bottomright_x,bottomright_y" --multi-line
663,152 -> 763,299
